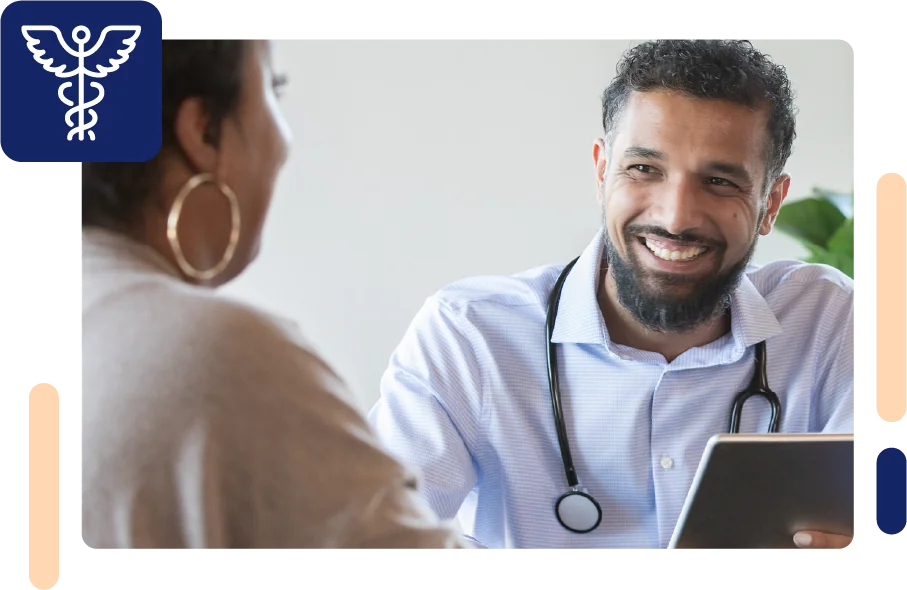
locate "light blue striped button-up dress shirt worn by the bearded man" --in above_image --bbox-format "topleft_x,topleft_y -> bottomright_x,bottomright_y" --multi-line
369,230 -> 856,551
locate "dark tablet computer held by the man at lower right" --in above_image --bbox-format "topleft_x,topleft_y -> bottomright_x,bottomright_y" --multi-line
668,434 -> 856,551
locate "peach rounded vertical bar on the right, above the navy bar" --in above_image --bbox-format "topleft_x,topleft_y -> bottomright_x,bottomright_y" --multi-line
873,172 -> 907,422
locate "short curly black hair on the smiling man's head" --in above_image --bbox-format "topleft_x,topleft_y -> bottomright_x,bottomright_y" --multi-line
602,39 -> 796,193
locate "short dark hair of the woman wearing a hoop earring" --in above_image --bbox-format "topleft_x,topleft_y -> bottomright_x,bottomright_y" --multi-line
81,33 -> 261,229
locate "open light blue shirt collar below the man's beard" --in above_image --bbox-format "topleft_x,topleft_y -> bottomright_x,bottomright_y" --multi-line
551,228 -> 782,362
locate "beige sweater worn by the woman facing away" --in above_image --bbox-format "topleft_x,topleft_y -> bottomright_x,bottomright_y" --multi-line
81,229 -> 463,551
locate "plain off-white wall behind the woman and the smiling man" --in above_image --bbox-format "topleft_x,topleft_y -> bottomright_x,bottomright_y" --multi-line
218,33 -> 855,409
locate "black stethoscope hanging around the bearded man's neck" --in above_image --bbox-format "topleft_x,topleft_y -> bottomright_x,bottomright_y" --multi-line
546,258 -> 781,533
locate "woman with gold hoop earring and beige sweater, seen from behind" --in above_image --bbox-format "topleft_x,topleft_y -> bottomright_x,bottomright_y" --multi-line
81,33 -> 461,551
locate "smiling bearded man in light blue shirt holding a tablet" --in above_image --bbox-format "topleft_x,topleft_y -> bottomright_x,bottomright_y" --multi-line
370,40 -> 855,550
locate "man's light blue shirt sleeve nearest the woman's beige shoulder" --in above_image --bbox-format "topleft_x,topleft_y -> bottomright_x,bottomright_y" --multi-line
369,297 -> 482,519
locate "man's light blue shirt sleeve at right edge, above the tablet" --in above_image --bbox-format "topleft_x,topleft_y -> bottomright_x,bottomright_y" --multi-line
813,290 -> 857,434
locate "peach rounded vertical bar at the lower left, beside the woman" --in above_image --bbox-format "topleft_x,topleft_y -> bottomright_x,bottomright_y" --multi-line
25,382 -> 63,590
